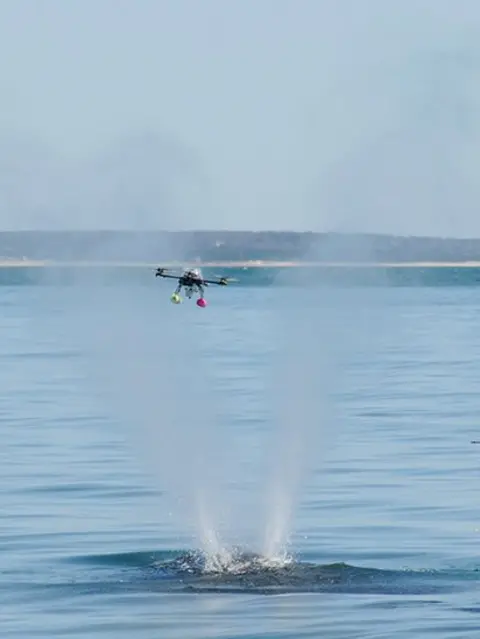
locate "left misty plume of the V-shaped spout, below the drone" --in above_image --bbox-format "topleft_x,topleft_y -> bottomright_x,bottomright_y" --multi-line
45,234 -> 234,555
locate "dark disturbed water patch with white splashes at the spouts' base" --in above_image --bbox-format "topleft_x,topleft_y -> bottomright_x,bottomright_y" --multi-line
54,551 -> 480,596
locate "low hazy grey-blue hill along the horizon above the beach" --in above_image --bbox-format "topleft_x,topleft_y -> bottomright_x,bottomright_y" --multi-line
0,230 -> 480,262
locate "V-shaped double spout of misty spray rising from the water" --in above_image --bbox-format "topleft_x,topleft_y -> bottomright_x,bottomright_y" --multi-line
41,232 -> 390,570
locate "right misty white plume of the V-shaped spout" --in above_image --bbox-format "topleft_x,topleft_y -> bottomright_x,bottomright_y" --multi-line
263,237 -> 384,558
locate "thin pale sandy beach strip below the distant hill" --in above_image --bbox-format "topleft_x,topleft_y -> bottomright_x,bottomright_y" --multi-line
0,260 -> 480,269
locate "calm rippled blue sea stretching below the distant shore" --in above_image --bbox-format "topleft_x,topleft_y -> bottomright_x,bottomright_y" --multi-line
0,269 -> 480,639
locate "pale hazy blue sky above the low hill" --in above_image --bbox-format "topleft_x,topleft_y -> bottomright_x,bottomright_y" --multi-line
0,0 -> 480,237
